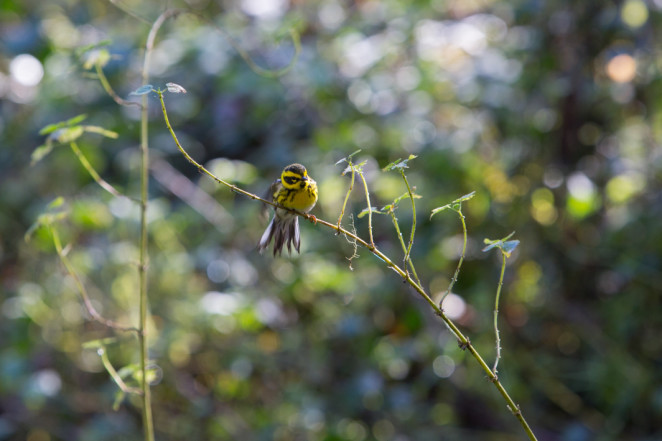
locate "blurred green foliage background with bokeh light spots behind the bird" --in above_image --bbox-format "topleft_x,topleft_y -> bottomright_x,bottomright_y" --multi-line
0,0 -> 662,441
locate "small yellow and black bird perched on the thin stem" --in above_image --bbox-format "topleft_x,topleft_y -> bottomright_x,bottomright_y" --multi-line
257,163 -> 317,256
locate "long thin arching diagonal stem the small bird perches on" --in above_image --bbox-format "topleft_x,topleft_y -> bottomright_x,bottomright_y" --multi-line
156,90 -> 537,441
